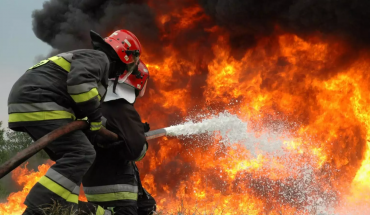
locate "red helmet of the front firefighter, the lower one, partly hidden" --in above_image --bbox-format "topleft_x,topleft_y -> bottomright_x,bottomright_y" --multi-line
118,60 -> 149,97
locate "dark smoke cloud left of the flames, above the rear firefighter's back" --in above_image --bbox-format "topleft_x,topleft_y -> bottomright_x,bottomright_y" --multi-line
32,0 -> 160,60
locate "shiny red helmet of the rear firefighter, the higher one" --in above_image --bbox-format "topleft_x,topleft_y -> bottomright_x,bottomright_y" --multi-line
104,30 -> 141,66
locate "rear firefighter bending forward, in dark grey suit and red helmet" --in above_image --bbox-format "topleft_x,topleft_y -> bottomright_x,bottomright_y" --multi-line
8,30 -> 141,215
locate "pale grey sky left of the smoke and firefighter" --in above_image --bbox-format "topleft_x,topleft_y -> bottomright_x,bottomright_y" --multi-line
0,0 -> 51,127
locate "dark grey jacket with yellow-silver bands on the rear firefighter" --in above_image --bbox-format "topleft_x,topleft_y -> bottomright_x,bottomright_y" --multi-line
8,49 -> 109,130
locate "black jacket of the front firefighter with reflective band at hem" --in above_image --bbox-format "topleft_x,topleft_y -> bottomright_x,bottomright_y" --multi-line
82,99 -> 155,212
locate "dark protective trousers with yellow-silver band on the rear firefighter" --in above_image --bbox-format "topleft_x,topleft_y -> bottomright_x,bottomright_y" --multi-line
20,120 -> 95,215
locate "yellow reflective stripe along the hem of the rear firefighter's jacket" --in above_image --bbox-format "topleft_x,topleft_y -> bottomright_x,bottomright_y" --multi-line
9,110 -> 76,122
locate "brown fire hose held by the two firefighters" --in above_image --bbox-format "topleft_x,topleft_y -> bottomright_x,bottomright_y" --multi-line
0,121 -> 167,179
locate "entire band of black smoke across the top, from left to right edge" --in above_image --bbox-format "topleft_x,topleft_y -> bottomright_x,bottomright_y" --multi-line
33,0 -> 370,60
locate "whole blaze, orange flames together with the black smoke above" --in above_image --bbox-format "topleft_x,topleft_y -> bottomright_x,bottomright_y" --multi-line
0,0 -> 370,215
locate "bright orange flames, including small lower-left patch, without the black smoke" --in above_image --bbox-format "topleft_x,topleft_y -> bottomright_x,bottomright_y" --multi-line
0,0 -> 370,215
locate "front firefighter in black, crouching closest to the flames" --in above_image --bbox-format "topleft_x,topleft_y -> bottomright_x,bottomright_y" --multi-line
82,59 -> 156,215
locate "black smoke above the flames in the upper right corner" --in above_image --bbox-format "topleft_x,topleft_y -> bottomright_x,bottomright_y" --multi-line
199,0 -> 370,58
